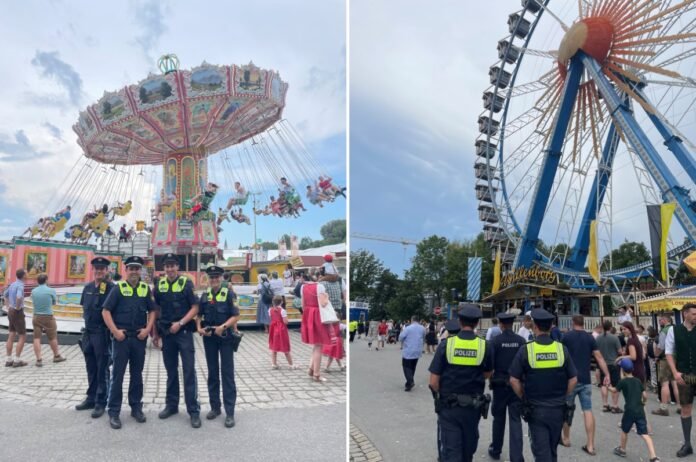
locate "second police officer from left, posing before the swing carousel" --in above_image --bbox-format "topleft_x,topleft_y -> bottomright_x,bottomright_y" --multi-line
102,257 -> 157,430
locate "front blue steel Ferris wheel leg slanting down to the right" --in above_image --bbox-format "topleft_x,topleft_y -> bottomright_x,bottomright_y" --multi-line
575,51 -> 696,244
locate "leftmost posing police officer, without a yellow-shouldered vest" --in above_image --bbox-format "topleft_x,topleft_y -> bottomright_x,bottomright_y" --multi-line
75,257 -> 114,419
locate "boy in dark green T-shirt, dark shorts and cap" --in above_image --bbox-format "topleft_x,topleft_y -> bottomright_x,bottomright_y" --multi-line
609,358 -> 660,462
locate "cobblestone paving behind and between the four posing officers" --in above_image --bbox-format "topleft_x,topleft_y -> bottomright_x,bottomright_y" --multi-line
0,331 -> 346,412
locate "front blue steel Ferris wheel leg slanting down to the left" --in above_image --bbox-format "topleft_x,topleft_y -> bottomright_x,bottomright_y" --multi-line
514,56 -> 583,268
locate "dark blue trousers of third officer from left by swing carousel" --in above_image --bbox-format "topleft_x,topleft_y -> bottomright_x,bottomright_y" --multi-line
162,329 -> 201,415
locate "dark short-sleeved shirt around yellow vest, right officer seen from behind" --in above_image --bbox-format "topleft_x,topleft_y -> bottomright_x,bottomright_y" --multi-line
509,334 -> 578,407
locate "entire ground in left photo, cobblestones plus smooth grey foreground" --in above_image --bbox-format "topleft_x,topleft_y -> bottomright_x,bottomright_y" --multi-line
0,331 -> 347,462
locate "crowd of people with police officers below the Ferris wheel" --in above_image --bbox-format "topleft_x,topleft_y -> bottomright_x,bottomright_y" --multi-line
348,304 -> 696,462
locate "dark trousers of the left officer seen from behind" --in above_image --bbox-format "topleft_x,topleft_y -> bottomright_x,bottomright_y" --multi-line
437,407 -> 481,462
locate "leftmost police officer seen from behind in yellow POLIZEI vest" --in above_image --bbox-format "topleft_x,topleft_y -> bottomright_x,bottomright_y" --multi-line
429,304 -> 493,462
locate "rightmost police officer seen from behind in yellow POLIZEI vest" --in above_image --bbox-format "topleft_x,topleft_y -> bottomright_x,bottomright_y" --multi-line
509,308 -> 578,462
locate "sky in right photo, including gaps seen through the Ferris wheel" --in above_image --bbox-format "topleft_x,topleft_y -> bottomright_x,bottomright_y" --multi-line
349,0 -> 696,274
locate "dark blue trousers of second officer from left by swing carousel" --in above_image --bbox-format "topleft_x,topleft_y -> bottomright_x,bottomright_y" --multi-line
108,337 -> 147,416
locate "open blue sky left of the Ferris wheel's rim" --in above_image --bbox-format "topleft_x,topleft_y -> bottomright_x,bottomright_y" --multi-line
350,0 -> 502,274
